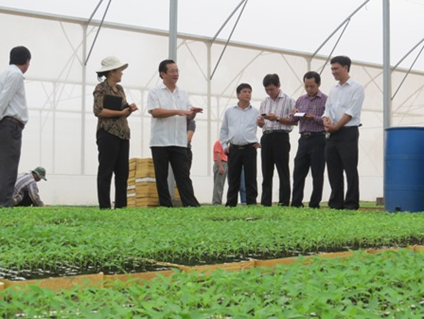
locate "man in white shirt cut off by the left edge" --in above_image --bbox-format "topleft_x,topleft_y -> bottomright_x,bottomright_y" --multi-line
0,46 -> 31,207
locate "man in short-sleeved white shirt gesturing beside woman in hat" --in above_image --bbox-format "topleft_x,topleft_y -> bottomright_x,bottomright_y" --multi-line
147,60 -> 202,207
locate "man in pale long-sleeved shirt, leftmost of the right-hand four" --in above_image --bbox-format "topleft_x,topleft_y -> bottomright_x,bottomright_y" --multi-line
219,83 -> 260,207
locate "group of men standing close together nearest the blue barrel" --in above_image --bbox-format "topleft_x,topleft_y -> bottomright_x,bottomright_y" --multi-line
213,56 -> 365,210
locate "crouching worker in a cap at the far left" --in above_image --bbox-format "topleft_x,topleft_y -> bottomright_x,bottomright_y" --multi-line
12,167 -> 47,206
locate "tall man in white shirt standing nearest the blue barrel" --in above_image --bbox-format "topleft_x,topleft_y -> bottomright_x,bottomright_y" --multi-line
322,56 -> 365,210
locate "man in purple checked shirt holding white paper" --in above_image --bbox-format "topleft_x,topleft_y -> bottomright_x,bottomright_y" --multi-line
290,71 -> 327,208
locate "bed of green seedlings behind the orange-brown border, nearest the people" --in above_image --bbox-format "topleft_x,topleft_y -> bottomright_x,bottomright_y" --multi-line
0,206 -> 424,277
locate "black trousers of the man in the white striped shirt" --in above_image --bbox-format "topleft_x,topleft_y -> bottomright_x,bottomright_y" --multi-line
261,132 -> 290,206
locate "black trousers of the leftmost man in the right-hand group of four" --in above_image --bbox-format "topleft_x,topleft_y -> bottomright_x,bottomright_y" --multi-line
225,145 -> 258,207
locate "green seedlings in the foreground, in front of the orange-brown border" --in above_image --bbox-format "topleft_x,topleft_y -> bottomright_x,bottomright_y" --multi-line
0,250 -> 424,319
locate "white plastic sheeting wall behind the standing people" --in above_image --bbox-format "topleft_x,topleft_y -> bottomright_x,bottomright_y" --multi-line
0,11 -> 424,205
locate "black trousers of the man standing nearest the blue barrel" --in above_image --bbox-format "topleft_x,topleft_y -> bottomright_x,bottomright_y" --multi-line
325,126 -> 359,210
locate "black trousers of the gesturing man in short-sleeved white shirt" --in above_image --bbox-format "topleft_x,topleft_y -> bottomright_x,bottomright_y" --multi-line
151,146 -> 200,207
